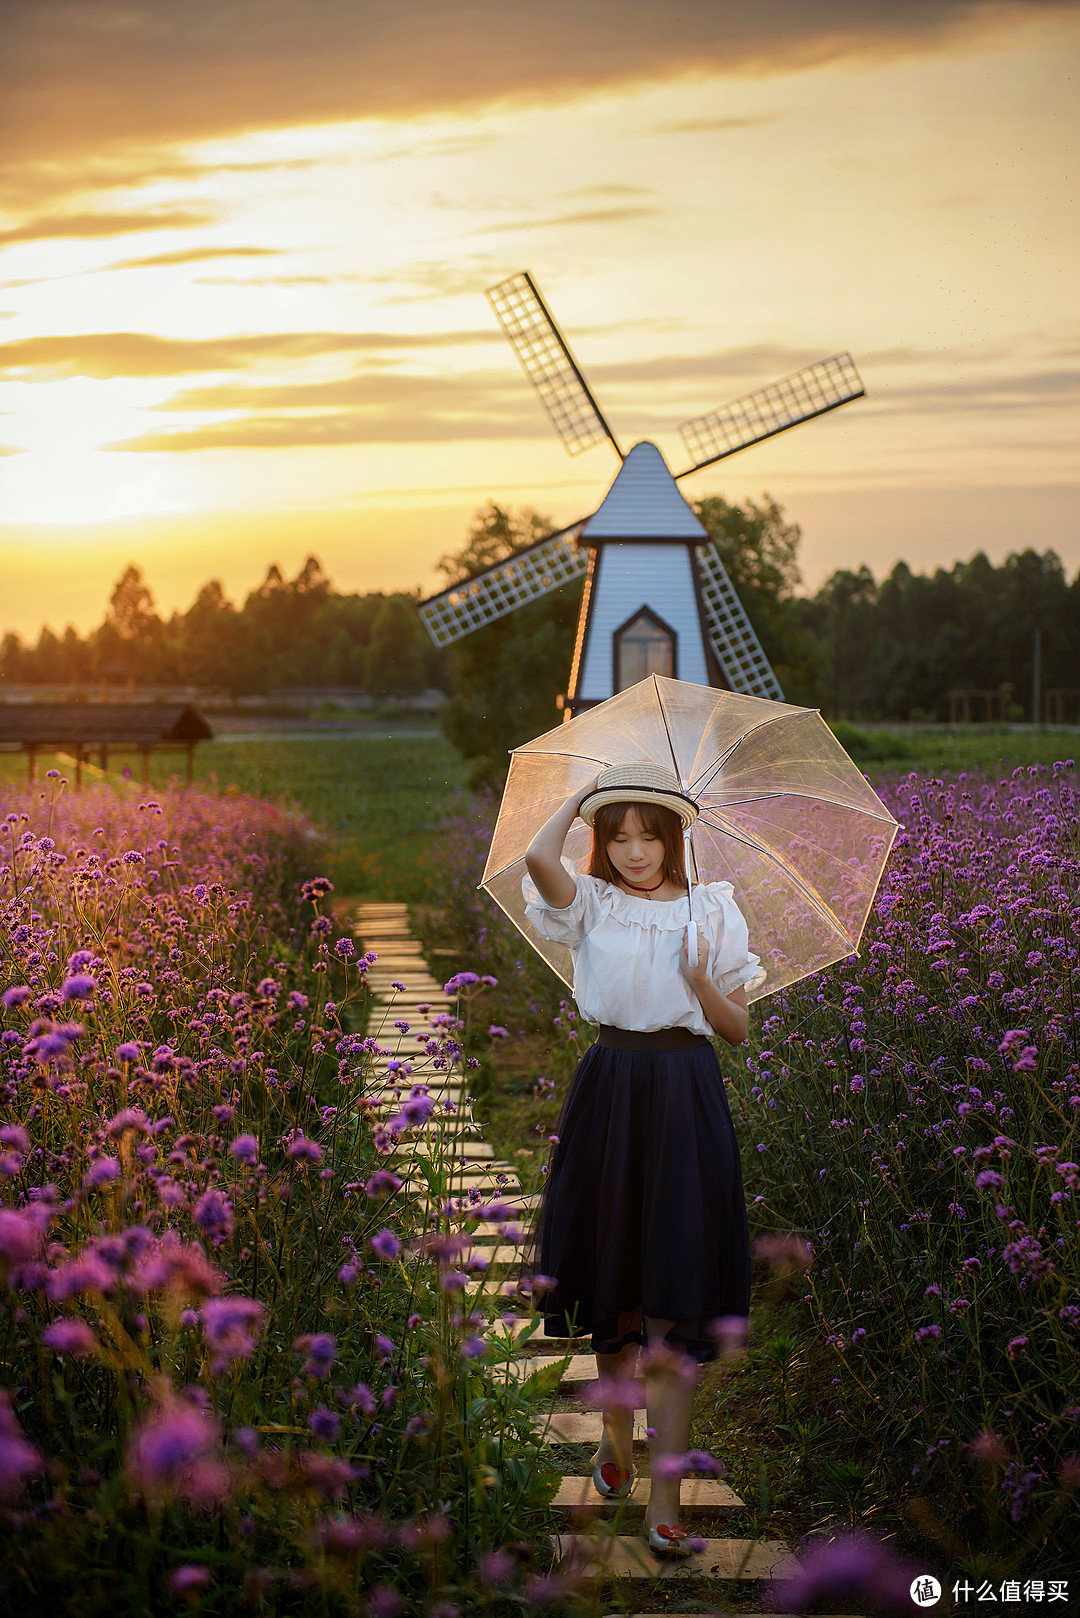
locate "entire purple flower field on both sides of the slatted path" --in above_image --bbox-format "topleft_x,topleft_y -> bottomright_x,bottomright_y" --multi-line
0,750 -> 1080,1618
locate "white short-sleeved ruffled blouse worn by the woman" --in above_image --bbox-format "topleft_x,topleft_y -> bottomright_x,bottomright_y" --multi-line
521,858 -> 766,1037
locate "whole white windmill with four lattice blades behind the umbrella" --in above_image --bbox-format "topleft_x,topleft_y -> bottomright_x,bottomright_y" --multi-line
419,270 -> 865,718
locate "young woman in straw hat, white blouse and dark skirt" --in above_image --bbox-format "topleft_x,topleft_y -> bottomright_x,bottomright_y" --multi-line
521,764 -> 764,1555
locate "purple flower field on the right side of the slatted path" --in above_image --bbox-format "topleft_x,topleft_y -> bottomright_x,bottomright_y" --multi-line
429,760 -> 1080,1574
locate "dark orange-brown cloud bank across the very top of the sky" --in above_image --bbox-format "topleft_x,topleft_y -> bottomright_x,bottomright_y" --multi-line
0,0 -> 1075,191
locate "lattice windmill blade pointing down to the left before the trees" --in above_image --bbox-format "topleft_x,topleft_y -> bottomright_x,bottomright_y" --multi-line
419,518 -> 589,646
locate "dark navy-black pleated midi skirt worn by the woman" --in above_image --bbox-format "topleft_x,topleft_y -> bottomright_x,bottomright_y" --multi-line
521,1029 -> 750,1364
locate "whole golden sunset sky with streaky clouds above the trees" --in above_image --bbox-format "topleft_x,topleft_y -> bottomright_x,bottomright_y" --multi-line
0,0 -> 1080,634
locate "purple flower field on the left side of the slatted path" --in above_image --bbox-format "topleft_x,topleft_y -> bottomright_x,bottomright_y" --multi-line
0,783 -> 569,1618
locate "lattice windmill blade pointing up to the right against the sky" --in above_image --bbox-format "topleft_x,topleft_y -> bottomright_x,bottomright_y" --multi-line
675,353 -> 866,477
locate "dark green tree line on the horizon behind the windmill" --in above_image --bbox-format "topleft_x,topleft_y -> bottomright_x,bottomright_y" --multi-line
0,495 -> 1080,757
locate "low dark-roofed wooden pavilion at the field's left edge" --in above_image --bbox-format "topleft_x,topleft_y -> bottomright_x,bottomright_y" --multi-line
0,702 -> 214,786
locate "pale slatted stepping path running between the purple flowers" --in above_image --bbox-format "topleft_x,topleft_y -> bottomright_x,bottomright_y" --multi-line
353,904 -> 841,1618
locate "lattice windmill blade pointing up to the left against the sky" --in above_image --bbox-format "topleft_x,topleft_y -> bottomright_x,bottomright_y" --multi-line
484,270 -> 622,460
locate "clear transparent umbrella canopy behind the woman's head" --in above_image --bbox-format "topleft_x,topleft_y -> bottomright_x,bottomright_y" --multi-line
481,675 -> 899,1000
